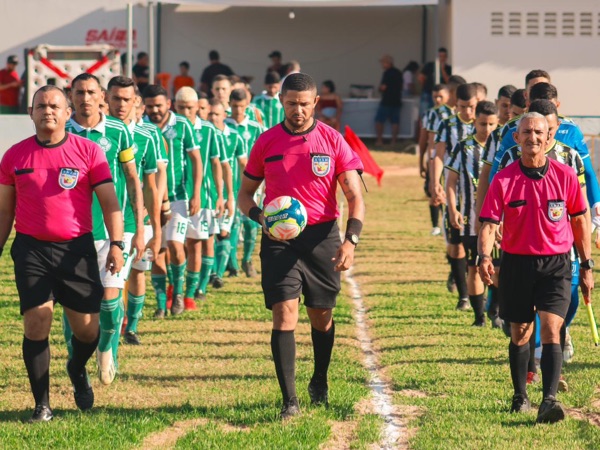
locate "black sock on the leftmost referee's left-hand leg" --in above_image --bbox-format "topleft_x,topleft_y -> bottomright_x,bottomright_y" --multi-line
23,336 -> 50,407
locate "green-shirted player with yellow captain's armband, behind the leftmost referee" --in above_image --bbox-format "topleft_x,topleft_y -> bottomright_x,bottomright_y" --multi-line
63,73 -> 145,384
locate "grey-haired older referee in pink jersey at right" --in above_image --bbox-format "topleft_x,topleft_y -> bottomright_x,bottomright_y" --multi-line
478,113 -> 594,423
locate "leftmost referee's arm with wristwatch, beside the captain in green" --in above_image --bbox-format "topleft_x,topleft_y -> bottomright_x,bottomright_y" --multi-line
94,182 -> 124,275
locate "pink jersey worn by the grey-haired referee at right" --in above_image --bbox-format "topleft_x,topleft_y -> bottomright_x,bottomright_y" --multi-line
480,158 -> 587,256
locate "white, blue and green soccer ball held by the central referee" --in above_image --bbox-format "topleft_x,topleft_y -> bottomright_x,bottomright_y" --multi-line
264,195 -> 308,241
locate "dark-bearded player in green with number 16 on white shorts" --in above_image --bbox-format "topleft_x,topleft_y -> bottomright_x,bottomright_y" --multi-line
143,85 -> 202,317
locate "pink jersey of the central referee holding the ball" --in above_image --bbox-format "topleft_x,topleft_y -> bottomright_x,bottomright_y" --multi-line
244,120 -> 363,225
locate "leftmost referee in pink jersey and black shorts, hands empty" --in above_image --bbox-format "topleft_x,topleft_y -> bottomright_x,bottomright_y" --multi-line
0,86 -> 123,422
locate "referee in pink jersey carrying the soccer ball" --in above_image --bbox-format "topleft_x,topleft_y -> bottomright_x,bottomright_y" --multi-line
238,73 -> 365,419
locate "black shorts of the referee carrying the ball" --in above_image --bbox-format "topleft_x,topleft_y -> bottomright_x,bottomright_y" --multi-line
260,221 -> 341,309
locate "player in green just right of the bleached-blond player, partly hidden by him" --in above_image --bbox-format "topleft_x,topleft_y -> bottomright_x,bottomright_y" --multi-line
209,98 -> 248,289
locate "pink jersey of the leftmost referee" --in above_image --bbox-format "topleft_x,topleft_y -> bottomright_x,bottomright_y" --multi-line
0,133 -> 112,242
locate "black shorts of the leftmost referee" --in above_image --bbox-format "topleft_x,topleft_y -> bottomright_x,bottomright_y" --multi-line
10,233 -> 104,314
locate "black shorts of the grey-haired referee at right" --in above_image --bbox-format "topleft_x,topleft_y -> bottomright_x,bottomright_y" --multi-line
499,252 -> 572,323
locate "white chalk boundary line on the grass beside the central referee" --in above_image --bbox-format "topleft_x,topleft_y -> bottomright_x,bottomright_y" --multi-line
345,267 -> 405,450
